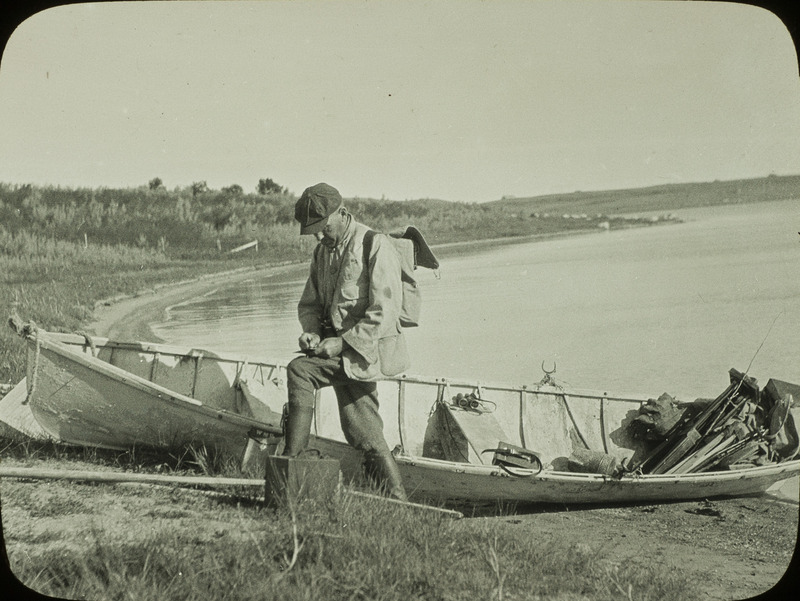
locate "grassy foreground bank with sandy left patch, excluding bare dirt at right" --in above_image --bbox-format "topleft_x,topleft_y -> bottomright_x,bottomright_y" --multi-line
3,468 -> 694,601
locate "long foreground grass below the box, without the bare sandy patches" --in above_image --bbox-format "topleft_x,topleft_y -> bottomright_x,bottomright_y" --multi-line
6,488 -> 692,601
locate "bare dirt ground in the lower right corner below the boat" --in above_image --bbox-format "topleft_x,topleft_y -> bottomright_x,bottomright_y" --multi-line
490,496 -> 800,601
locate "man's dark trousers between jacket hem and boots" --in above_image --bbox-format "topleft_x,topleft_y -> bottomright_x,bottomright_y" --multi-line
286,357 -> 389,454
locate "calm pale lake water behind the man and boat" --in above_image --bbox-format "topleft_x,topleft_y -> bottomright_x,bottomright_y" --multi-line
153,201 -> 800,400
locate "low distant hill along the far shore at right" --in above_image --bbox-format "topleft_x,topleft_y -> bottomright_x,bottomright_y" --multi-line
484,175 -> 800,215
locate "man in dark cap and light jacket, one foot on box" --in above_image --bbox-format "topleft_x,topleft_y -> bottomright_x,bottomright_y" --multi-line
283,183 -> 409,500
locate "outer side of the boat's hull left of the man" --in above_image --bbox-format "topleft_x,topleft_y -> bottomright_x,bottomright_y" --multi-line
28,338 -> 280,454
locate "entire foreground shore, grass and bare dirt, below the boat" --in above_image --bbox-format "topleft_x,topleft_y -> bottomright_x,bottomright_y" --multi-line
0,442 -> 797,601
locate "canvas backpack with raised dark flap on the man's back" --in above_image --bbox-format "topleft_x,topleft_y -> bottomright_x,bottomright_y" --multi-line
363,226 -> 439,328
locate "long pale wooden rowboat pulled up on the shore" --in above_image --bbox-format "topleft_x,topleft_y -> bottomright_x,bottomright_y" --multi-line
7,326 -> 800,504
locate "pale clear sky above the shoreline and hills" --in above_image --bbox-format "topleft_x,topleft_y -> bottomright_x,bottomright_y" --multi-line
0,0 -> 800,202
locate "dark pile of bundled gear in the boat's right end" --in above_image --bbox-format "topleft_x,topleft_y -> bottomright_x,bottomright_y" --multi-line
626,369 -> 800,474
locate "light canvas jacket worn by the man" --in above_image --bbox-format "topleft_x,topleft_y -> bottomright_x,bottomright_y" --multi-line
297,218 -> 409,380
